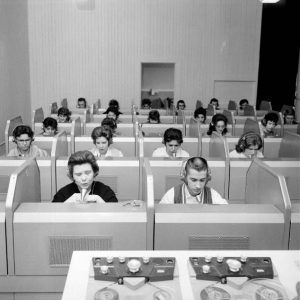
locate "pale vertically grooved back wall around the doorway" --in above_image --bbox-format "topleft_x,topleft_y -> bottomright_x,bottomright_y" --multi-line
28,0 -> 262,108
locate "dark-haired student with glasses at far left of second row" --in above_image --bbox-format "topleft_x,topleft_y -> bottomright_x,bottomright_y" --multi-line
7,125 -> 48,157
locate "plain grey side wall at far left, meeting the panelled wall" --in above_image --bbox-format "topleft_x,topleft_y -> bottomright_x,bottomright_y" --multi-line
0,0 -> 31,143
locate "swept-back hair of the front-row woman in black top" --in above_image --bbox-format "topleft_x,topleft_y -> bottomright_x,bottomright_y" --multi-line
68,150 -> 99,179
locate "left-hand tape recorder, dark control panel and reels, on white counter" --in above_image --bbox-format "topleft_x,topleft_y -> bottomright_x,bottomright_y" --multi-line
86,256 -> 182,300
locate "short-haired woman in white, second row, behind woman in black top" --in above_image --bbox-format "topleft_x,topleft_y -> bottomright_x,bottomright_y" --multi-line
90,127 -> 124,157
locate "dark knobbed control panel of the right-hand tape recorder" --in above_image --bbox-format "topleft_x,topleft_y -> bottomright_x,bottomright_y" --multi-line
190,256 -> 274,283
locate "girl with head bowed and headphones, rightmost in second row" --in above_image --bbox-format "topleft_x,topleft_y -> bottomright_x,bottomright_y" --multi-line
229,131 -> 264,158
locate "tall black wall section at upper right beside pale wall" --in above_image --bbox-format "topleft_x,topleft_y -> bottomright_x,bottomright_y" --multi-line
257,0 -> 300,110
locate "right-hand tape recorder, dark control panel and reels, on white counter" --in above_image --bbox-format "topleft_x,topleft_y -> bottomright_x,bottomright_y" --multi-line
189,256 -> 288,300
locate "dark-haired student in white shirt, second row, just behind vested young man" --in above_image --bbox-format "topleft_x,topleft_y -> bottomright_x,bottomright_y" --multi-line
152,128 -> 190,157
